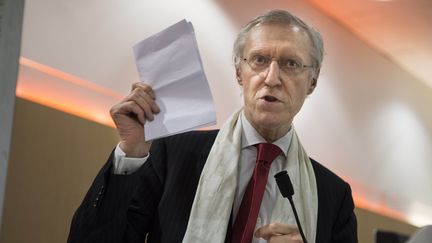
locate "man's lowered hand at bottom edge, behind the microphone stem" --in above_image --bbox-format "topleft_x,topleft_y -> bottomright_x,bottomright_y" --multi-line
255,223 -> 303,243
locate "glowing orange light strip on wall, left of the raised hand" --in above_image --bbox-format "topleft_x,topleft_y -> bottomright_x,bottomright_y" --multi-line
16,57 -> 121,127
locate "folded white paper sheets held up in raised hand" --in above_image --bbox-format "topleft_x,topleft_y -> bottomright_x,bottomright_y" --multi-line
133,20 -> 216,140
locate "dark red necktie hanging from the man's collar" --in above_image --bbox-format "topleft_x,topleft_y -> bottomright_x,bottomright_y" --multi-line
232,143 -> 282,243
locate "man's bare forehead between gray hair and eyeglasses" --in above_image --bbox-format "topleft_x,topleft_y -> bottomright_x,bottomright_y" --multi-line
243,24 -> 312,60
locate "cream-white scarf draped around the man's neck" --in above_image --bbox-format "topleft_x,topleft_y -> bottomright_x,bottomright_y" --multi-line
183,110 -> 318,243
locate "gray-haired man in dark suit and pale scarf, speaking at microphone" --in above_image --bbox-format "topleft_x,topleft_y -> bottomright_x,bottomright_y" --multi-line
69,10 -> 357,243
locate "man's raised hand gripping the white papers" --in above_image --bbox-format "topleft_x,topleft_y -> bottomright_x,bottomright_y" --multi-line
110,82 -> 160,158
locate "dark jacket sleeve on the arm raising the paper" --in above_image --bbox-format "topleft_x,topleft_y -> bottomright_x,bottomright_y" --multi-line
67,138 -> 165,243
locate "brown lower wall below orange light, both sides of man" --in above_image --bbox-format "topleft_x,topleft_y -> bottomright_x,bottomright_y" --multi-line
0,99 -> 415,243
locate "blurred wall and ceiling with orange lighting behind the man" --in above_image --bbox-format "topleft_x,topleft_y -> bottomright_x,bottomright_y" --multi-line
0,0 -> 432,243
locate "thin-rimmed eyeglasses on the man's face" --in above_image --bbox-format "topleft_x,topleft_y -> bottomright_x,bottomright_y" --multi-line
242,54 -> 314,76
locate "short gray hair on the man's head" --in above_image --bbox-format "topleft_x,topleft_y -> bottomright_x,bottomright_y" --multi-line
233,10 -> 324,76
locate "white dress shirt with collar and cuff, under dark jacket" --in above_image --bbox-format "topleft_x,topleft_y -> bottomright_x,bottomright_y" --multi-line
113,113 -> 292,243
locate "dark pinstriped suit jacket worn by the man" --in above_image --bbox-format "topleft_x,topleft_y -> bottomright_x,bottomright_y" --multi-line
68,131 -> 357,243
